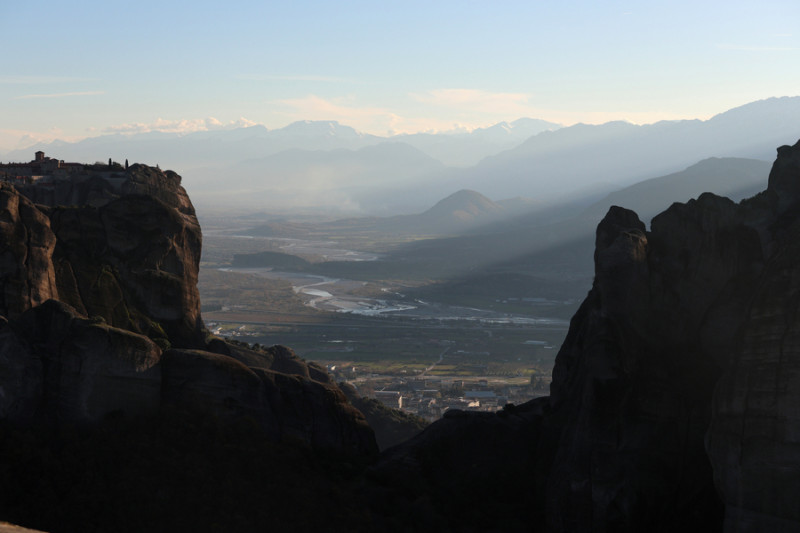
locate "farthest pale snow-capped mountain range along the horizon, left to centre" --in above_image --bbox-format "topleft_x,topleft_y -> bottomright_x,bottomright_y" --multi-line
3,118 -> 561,170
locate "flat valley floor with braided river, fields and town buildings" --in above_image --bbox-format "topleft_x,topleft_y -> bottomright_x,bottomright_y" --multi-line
199,215 -> 577,420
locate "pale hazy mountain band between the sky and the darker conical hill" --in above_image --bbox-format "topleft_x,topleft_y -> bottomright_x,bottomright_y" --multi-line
0,96 -> 800,216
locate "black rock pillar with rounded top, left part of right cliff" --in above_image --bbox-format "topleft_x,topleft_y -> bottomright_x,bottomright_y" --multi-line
539,199 -> 719,531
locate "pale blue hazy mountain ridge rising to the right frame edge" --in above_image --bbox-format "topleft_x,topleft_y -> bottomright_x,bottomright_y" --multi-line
459,97 -> 800,198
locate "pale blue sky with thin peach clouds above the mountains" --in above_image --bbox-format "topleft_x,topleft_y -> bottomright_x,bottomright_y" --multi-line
0,0 -> 800,150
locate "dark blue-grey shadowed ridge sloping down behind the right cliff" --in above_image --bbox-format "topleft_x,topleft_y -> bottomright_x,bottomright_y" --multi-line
385,154 -> 771,312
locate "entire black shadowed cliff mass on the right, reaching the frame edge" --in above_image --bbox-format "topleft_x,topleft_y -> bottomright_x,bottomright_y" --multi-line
376,139 -> 800,532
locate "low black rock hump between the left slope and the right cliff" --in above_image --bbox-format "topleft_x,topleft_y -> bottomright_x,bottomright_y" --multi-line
369,398 -> 548,533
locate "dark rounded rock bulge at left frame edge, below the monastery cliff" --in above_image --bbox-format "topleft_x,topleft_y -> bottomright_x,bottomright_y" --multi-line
0,300 -> 161,423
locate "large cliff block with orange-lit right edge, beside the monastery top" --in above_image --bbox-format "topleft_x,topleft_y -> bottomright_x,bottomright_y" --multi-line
31,165 -> 203,347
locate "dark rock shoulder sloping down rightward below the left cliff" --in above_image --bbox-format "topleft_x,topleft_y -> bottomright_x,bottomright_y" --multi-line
162,347 -> 377,455
